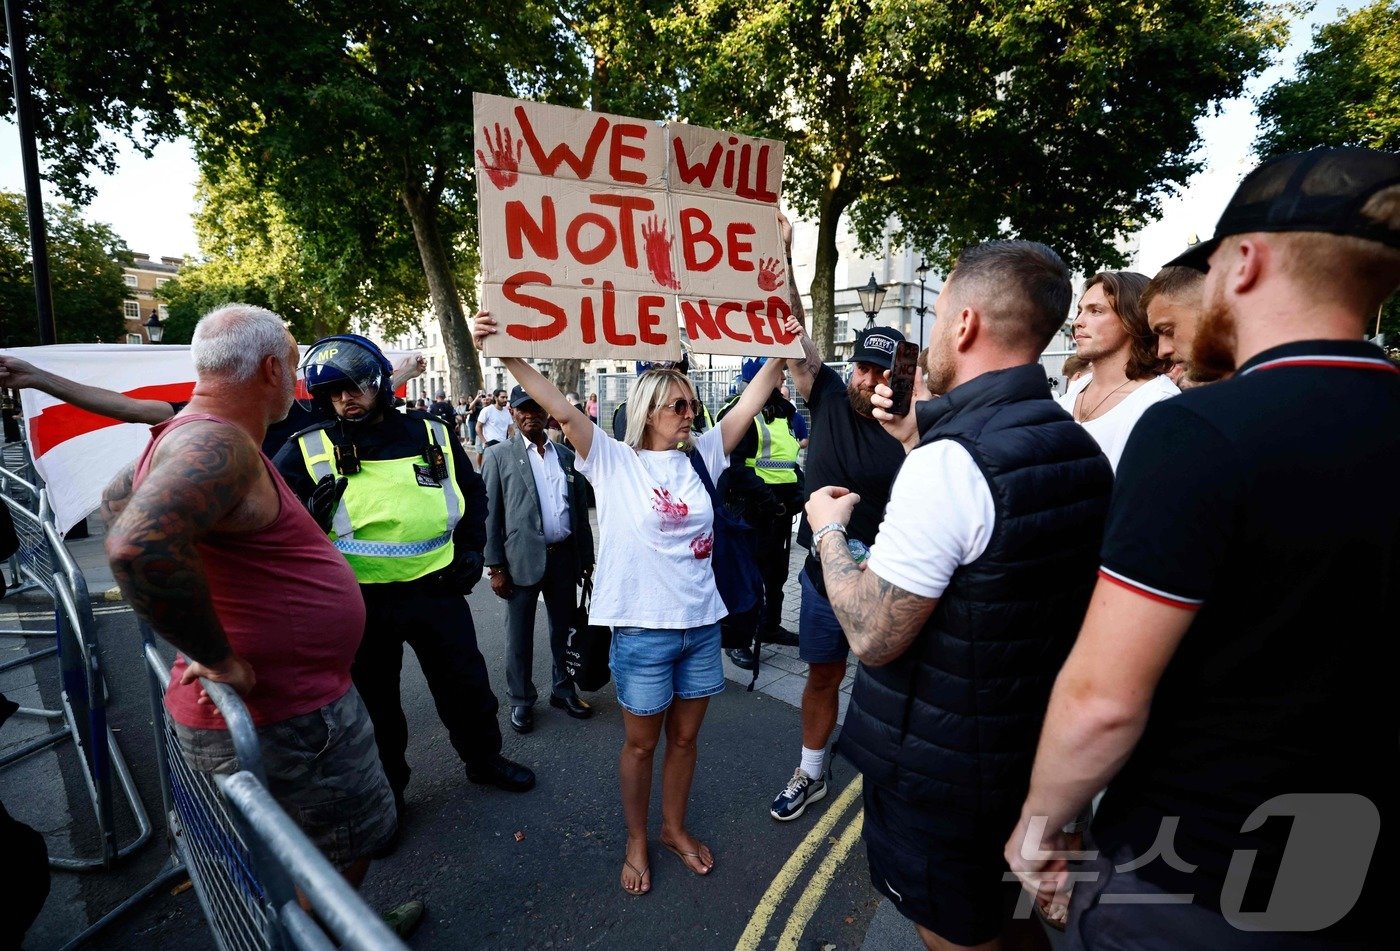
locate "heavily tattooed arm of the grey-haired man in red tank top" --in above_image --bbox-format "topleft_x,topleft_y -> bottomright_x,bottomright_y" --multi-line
104,423 -> 262,665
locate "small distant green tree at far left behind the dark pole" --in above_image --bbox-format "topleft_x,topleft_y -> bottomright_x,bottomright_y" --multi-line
0,192 -> 132,347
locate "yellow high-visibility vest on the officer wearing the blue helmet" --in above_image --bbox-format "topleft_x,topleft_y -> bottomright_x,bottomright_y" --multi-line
297,419 -> 466,584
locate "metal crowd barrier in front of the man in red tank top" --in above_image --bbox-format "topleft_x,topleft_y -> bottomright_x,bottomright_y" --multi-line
77,623 -> 405,951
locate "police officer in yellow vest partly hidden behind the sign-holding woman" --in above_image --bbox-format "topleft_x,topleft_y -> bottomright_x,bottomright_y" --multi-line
718,357 -> 802,668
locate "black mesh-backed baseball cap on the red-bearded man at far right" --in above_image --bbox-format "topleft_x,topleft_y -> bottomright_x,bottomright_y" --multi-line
1168,148 -> 1400,270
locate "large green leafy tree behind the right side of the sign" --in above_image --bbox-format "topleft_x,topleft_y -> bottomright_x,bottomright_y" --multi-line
662,0 -> 1284,352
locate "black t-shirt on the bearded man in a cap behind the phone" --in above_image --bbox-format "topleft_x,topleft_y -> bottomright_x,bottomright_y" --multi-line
797,366 -> 904,568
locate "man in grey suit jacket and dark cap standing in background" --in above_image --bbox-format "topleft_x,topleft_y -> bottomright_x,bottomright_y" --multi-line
482,387 -> 594,733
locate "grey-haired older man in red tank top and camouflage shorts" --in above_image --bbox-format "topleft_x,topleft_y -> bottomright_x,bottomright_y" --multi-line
102,304 -> 423,934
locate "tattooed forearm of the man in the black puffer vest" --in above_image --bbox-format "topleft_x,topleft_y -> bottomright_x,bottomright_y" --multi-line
822,535 -> 938,667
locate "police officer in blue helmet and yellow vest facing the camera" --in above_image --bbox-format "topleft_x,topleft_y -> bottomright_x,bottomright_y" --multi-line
273,333 -> 535,834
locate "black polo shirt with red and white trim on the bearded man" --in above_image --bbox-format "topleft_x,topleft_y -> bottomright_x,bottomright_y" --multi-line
1095,340 -> 1400,916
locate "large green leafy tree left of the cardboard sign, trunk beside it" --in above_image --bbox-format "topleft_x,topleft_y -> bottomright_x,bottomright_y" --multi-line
5,0 -> 582,392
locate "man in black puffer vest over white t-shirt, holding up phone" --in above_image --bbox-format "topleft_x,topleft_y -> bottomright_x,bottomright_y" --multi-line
806,241 -> 1113,948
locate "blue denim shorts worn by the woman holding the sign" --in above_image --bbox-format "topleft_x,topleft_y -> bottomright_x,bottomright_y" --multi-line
608,622 -> 724,717
